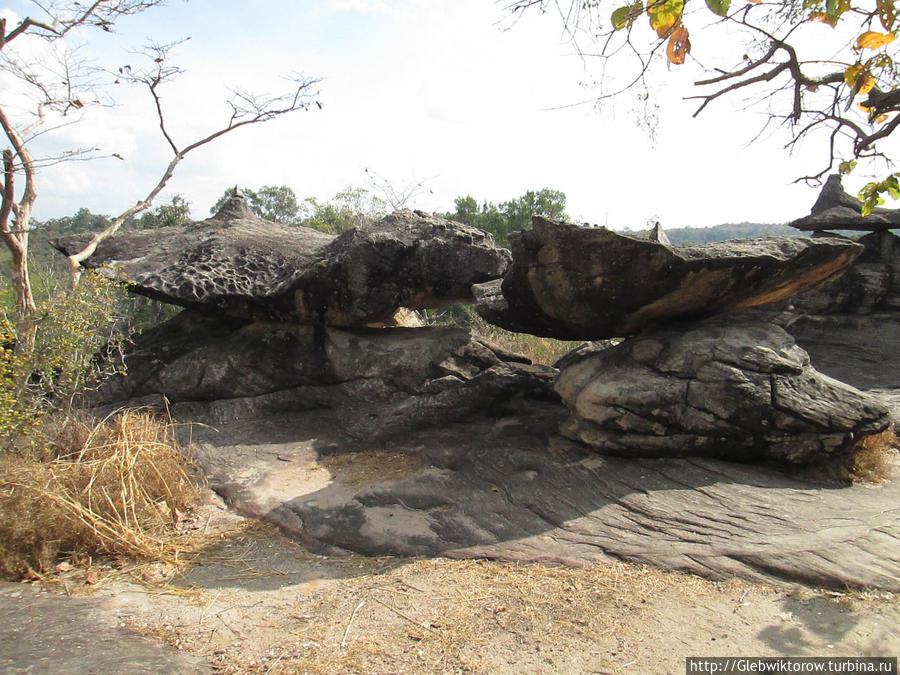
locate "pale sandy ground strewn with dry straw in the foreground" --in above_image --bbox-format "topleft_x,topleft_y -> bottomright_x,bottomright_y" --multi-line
24,492 -> 900,674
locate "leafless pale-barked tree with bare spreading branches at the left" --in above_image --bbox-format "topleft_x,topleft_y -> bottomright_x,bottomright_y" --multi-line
0,0 -> 321,342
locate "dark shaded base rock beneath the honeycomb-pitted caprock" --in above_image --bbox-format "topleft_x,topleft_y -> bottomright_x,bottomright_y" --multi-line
91,310 -> 556,438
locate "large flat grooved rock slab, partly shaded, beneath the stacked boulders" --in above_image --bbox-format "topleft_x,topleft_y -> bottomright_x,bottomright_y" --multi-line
194,402 -> 900,592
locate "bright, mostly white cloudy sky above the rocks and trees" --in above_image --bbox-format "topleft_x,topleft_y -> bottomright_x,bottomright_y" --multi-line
0,0 -> 896,229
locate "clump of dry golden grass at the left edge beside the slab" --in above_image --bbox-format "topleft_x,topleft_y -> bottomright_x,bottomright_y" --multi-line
0,411 -> 197,578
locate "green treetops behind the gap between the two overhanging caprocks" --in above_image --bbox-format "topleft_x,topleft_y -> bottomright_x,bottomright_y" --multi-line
447,188 -> 569,246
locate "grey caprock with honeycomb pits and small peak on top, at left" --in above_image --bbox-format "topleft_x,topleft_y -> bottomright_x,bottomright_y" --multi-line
52,196 -> 509,326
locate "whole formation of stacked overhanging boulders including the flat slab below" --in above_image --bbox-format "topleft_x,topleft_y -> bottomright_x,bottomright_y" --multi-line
59,185 -> 900,590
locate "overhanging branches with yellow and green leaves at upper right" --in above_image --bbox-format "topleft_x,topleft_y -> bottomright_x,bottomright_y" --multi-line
506,0 -> 900,208
